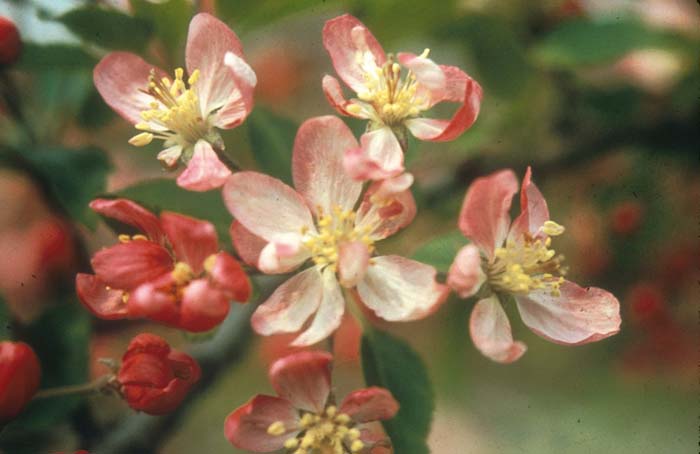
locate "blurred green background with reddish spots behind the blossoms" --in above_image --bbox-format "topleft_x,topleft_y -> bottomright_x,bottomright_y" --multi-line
0,0 -> 700,454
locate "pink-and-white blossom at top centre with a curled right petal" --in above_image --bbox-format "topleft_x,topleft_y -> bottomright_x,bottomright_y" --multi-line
323,14 -> 482,180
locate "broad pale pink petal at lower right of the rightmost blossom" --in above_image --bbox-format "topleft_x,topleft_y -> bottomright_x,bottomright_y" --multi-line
516,281 -> 621,345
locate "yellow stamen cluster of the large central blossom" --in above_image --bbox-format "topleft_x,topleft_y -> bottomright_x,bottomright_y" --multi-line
301,206 -> 374,271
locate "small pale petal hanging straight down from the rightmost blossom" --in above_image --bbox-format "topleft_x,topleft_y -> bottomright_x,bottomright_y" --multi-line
469,296 -> 527,364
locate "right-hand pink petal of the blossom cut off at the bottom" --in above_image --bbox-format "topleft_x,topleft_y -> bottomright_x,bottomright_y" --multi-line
340,386 -> 399,423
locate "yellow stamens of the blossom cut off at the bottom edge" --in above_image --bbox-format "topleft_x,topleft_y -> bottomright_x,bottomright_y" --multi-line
267,405 -> 365,454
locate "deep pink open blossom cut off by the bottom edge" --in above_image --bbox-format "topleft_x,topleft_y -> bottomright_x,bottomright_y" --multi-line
224,351 -> 399,454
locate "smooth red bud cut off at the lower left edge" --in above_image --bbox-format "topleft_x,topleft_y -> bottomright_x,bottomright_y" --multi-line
0,341 -> 41,424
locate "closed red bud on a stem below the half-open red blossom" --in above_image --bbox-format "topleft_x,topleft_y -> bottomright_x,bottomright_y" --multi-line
117,333 -> 201,415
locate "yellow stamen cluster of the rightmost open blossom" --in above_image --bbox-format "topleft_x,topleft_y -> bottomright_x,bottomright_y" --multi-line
487,221 -> 566,296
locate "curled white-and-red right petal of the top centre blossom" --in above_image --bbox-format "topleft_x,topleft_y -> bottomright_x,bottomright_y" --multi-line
404,79 -> 483,142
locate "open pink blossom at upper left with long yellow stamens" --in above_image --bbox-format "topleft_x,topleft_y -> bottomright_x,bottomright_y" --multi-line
94,13 -> 257,191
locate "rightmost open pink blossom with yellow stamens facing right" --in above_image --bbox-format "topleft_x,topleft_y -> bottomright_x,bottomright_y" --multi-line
447,168 -> 620,363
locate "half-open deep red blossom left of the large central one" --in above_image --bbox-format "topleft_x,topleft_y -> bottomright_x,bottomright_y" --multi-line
76,199 -> 251,332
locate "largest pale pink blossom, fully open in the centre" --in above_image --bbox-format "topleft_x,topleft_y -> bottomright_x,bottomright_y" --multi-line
223,116 -> 447,346
